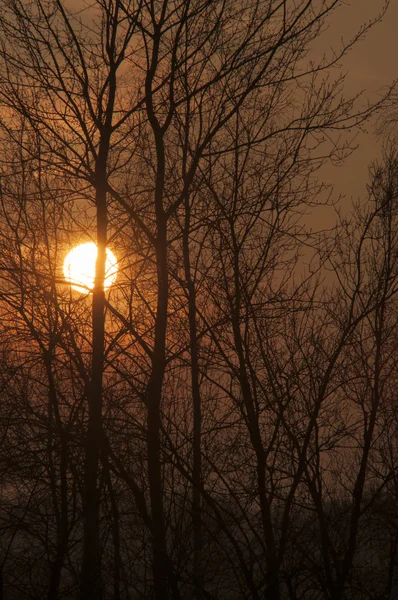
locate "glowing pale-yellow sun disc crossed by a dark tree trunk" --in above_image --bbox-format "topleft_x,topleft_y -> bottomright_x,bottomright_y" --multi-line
64,242 -> 117,294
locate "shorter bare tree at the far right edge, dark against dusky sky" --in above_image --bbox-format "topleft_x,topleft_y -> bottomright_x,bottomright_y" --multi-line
290,146 -> 398,600
